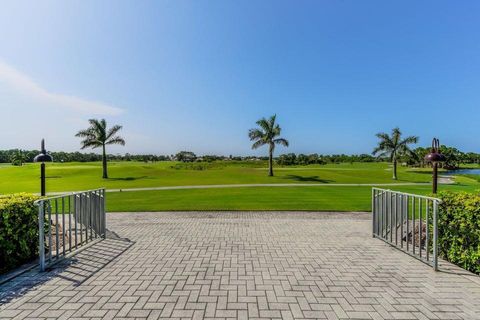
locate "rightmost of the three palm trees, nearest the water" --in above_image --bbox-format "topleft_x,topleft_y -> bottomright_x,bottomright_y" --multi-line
372,127 -> 418,180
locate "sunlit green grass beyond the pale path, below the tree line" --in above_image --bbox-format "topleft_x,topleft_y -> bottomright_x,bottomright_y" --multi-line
0,161 -> 430,194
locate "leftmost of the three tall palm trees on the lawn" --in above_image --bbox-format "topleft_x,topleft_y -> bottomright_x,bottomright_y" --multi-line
75,119 -> 125,179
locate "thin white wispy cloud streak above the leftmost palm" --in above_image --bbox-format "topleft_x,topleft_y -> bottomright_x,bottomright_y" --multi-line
0,60 -> 123,115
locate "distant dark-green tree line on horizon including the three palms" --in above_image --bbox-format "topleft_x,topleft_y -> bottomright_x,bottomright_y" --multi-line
4,115 -> 480,179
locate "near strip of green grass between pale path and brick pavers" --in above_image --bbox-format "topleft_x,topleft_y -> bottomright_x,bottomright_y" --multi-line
107,185 -> 475,212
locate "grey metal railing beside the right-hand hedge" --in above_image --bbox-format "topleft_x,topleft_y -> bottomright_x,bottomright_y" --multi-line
372,188 -> 440,270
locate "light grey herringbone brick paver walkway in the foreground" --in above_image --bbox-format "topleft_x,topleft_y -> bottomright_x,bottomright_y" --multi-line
0,212 -> 480,319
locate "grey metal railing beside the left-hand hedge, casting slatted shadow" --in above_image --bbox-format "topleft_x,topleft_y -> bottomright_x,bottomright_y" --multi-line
36,189 -> 106,271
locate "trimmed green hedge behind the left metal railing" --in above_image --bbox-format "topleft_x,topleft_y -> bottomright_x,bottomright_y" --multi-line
0,193 -> 38,273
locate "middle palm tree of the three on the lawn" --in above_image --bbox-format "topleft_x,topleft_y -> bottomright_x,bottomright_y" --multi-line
248,114 -> 288,177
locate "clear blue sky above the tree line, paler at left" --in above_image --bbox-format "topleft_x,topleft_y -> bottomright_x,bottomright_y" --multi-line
0,0 -> 480,155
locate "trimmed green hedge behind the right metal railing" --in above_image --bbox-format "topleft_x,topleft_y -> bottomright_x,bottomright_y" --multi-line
438,192 -> 480,274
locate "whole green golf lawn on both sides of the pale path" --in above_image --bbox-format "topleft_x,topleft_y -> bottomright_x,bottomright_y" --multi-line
0,161 -> 480,211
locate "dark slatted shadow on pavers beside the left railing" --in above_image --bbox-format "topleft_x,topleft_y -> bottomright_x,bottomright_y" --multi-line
0,230 -> 135,306
